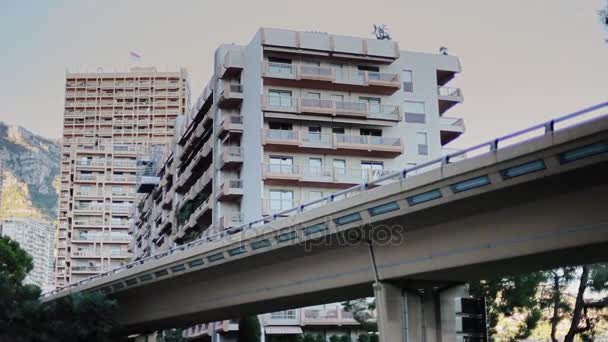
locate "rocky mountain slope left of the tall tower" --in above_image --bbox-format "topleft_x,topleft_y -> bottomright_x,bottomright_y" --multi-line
0,122 -> 61,221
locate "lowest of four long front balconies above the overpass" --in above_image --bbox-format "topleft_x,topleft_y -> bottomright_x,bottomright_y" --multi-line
262,164 -> 394,188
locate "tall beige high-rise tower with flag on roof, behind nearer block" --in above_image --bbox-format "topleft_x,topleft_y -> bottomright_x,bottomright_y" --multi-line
55,67 -> 190,286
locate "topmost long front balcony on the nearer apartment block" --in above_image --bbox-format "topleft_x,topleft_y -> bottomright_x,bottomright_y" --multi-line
262,62 -> 401,95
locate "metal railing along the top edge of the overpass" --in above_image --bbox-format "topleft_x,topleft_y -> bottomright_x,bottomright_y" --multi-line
42,102 -> 608,297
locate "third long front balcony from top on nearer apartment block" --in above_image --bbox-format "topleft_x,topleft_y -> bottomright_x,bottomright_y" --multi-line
262,129 -> 403,157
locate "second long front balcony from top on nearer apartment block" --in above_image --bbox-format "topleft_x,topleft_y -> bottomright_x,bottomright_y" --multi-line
262,96 -> 401,122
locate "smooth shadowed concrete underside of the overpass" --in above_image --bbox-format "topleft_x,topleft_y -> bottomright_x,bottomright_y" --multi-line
114,162 -> 608,332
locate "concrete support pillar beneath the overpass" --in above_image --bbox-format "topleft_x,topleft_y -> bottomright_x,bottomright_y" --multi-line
374,282 -> 468,342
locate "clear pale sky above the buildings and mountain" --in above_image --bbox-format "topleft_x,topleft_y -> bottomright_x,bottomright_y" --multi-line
0,0 -> 608,147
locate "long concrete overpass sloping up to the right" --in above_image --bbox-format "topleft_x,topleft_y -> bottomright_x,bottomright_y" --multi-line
43,103 -> 608,341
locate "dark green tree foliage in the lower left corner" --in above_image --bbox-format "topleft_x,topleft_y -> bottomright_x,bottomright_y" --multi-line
0,237 -> 121,342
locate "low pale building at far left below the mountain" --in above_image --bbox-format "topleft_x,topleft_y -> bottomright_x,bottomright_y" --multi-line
0,218 -> 55,291
